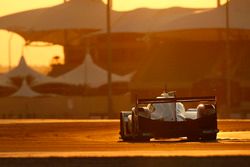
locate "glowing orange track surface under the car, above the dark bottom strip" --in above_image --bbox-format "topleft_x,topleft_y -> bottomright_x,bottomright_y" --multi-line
0,120 -> 250,157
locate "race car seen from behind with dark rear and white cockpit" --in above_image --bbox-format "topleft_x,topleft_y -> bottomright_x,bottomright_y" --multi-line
120,92 -> 219,141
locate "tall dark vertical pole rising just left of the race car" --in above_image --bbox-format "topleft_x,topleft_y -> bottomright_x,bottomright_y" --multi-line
107,0 -> 114,117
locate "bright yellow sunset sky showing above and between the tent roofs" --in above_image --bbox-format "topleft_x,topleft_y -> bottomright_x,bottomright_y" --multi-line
0,0 -> 226,70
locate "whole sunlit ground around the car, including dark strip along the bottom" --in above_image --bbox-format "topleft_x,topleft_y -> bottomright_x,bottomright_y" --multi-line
0,120 -> 250,166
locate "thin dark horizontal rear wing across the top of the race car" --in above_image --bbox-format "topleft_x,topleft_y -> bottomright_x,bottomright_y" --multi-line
136,96 -> 217,106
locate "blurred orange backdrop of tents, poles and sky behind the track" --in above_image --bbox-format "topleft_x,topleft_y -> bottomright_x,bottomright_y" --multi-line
0,0 -> 250,118
